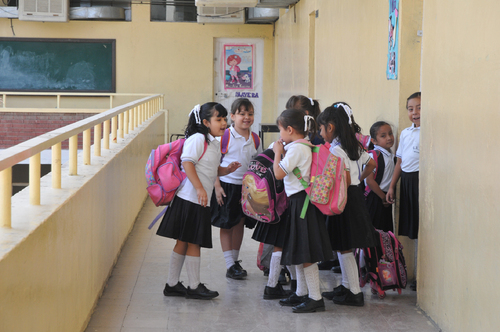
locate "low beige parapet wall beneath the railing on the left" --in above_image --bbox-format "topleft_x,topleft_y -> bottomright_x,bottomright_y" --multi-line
0,112 -> 165,332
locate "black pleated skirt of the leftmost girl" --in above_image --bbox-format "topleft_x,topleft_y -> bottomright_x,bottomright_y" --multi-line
156,196 -> 212,248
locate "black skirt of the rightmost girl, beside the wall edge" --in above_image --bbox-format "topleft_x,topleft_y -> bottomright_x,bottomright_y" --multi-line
398,172 -> 419,239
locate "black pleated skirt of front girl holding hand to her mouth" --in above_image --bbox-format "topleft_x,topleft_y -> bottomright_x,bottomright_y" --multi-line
281,191 -> 333,265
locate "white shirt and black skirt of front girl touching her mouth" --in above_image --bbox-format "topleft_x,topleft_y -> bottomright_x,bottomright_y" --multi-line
268,142 -> 333,265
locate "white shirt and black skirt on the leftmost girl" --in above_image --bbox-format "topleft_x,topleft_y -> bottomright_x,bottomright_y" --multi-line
156,133 -> 221,248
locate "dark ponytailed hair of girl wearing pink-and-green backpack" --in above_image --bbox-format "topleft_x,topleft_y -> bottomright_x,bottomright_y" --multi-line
318,102 -> 363,160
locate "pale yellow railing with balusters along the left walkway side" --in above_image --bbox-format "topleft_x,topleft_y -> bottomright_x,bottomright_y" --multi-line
0,93 -> 163,227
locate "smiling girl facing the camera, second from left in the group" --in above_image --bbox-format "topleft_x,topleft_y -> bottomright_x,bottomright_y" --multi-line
210,98 -> 262,279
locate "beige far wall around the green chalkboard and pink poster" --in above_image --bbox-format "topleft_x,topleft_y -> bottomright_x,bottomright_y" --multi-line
0,4 -> 274,140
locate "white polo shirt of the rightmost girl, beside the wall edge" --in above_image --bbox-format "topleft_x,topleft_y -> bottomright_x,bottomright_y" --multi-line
396,124 -> 420,173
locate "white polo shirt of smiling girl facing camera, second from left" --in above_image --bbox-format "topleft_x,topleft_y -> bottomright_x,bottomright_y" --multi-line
220,126 -> 262,185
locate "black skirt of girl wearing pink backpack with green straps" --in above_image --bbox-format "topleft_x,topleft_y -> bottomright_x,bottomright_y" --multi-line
327,186 -> 376,251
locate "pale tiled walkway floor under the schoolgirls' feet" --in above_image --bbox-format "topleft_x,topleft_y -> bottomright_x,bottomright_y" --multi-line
86,200 -> 439,332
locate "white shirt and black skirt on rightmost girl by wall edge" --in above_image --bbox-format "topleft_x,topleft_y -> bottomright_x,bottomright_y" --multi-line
396,124 -> 420,239
